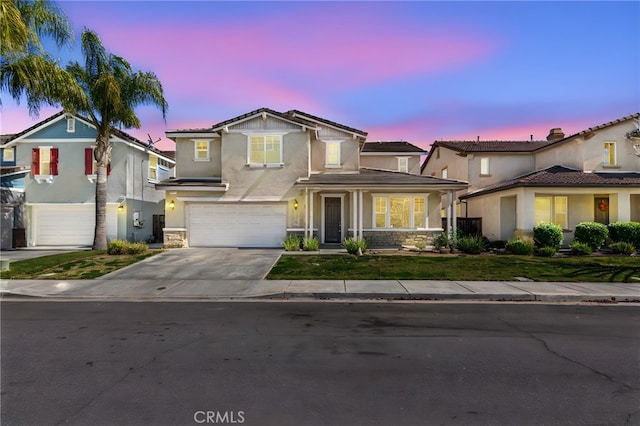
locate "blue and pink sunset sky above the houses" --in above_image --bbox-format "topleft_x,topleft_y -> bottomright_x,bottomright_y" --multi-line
0,1 -> 640,149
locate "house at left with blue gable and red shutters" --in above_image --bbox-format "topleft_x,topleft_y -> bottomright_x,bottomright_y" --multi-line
0,112 -> 175,248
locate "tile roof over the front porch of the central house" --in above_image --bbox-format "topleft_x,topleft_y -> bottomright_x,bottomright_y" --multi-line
297,168 -> 468,189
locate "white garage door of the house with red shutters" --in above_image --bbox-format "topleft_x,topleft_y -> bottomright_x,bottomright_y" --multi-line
33,204 -> 95,246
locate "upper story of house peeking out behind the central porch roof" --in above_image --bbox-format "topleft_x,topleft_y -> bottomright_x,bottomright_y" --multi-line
360,141 -> 428,175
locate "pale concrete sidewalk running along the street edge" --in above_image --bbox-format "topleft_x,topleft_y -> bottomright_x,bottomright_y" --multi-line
0,279 -> 640,303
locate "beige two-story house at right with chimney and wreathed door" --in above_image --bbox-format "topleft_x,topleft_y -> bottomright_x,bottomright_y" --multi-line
422,114 -> 640,243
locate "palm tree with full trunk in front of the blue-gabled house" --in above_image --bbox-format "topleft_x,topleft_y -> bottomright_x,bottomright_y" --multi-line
63,29 -> 168,250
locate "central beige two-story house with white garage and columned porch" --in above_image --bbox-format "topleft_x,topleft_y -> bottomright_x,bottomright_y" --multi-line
156,108 -> 466,247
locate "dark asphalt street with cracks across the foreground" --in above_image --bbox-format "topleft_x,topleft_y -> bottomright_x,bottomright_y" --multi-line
0,301 -> 640,425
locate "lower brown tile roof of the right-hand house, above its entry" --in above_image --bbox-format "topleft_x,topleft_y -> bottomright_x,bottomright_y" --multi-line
460,165 -> 640,199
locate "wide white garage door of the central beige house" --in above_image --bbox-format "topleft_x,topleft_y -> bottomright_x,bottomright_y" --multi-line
188,203 -> 286,247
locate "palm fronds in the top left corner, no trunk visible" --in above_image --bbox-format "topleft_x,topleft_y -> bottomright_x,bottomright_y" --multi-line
0,0 -> 79,117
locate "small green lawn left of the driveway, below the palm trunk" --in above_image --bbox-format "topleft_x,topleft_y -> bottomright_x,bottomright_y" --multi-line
0,250 -> 161,279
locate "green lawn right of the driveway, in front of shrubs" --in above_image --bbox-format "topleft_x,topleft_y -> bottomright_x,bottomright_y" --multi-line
267,254 -> 640,282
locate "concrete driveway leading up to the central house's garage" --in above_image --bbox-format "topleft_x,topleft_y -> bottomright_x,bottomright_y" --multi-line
99,248 -> 282,280
